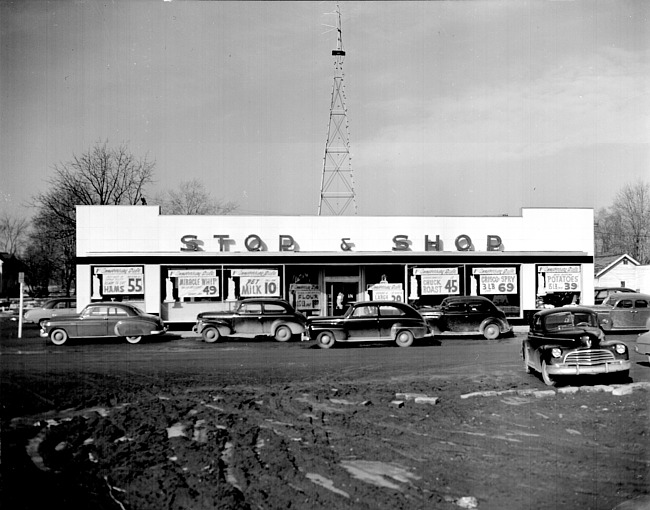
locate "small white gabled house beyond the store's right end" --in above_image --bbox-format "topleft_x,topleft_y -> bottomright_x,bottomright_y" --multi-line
594,254 -> 650,293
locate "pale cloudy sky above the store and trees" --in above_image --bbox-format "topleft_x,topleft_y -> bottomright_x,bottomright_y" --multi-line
0,0 -> 650,216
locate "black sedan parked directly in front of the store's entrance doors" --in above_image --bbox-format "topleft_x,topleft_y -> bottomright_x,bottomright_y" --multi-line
307,301 -> 433,349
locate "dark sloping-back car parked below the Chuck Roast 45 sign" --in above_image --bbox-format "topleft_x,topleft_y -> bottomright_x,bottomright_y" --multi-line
419,296 -> 512,340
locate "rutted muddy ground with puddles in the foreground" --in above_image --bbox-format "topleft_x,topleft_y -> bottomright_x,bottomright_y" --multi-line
1,366 -> 650,510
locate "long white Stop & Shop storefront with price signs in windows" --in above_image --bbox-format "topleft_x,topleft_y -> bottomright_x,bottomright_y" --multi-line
77,206 -> 594,323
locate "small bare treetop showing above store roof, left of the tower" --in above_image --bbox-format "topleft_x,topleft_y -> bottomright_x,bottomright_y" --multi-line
158,179 -> 238,215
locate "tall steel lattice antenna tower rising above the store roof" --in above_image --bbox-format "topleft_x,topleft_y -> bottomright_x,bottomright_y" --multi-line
318,3 -> 357,216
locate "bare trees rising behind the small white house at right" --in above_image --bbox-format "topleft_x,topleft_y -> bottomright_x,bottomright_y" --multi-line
596,181 -> 650,264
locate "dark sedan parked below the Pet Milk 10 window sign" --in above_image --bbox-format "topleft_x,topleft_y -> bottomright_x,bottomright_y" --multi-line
192,298 -> 307,343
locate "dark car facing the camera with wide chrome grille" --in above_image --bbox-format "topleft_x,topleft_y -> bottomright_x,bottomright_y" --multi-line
521,306 -> 630,386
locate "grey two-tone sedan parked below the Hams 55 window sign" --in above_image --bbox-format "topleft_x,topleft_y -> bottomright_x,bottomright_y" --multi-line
40,302 -> 168,345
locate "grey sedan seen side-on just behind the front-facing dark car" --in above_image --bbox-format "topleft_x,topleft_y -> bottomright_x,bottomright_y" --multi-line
594,292 -> 650,332
